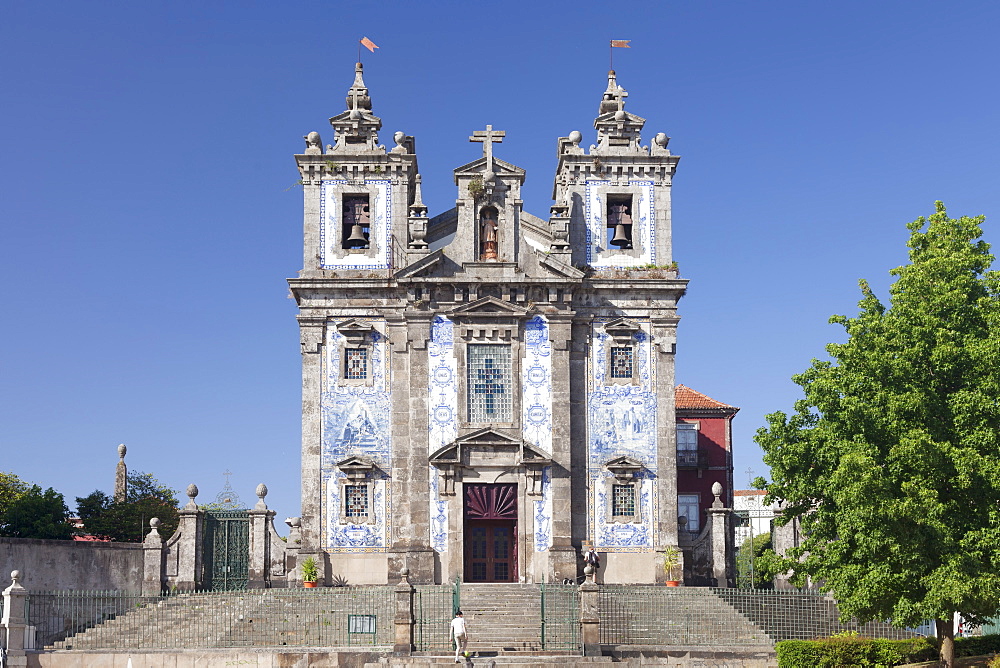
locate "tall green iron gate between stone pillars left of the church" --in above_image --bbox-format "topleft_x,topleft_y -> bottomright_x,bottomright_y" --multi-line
203,510 -> 250,591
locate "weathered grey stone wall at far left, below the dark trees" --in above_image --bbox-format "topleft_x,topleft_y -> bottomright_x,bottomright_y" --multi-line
0,538 -> 143,591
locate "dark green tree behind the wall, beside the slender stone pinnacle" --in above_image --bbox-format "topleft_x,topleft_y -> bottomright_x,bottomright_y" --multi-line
76,471 -> 178,543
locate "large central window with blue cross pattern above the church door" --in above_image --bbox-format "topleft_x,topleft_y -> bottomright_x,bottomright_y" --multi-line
466,344 -> 514,422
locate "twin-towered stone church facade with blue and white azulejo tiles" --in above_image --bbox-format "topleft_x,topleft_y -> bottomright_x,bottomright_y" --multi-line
289,63 -> 731,584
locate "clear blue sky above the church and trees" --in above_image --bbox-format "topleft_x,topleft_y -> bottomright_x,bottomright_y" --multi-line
0,0 -> 1000,529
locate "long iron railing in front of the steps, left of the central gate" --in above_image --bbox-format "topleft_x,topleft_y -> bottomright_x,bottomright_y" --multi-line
26,586 -> 395,649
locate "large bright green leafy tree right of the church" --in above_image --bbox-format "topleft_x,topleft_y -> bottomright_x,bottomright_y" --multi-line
755,202 -> 1000,666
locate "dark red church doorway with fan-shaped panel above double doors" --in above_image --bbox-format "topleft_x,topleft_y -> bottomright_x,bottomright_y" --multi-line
462,483 -> 518,582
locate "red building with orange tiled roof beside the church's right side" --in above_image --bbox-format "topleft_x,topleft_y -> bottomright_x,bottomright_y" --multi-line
675,385 -> 740,533
